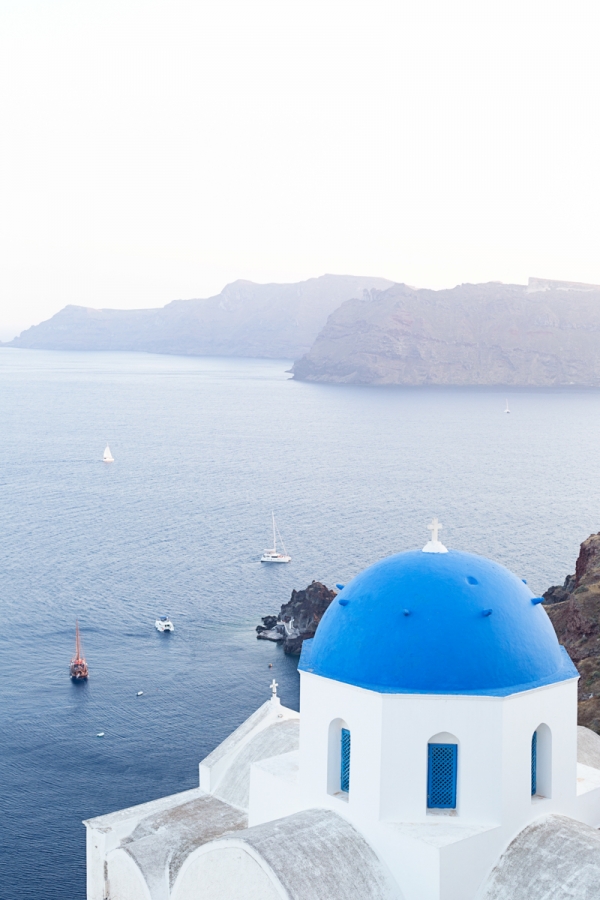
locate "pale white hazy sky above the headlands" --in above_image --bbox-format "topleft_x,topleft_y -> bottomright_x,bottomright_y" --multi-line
0,0 -> 600,338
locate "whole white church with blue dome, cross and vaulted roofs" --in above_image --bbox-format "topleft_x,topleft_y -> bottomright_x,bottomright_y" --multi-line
85,520 -> 600,900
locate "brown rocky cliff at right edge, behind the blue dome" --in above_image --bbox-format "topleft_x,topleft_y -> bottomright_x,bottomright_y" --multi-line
544,533 -> 600,734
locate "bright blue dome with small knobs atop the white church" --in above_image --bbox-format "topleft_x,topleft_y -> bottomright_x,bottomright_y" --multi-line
299,550 -> 578,696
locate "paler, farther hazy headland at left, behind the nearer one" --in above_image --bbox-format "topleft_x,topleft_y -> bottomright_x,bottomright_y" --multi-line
8,275 -> 392,359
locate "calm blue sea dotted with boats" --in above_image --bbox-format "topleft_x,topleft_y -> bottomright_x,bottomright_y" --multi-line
0,349 -> 600,900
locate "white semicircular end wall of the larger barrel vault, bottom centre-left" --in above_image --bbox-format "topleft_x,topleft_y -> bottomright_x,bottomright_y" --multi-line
170,841 -> 288,900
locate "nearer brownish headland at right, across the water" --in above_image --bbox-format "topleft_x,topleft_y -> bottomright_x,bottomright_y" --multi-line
293,279 -> 600,386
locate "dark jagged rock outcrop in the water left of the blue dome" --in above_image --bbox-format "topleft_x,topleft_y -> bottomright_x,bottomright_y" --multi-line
256,581 -> 337,656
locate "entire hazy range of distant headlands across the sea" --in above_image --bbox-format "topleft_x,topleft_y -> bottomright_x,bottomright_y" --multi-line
5,275 -> 600,387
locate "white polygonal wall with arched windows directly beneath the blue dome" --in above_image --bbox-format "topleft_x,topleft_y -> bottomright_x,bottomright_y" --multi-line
300,672 -> 577,831
